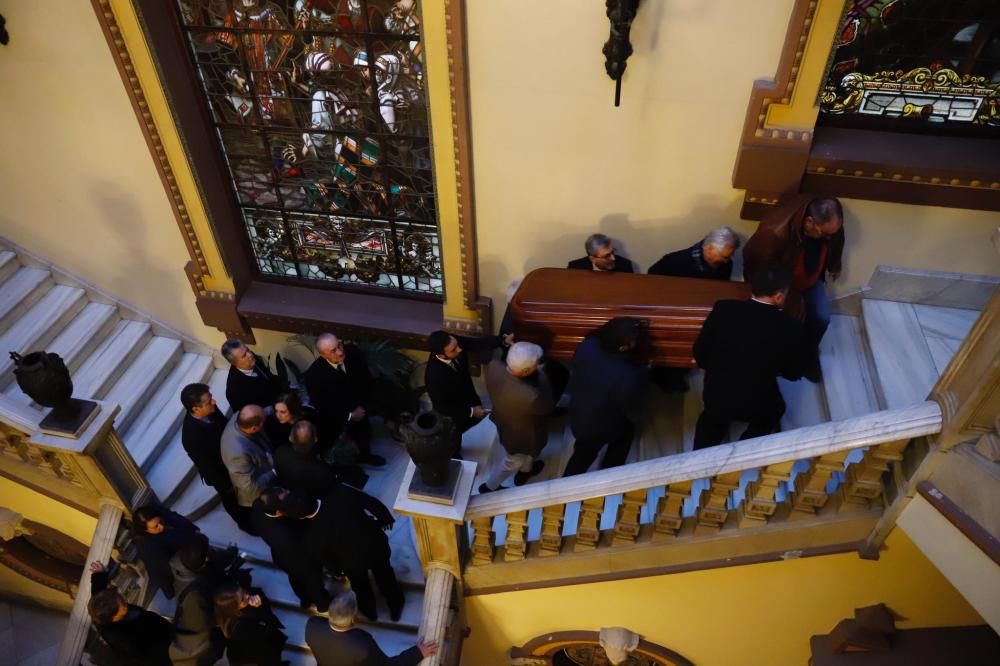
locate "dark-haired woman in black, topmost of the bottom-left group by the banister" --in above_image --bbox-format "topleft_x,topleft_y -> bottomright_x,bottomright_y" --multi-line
132,506 -> 199,599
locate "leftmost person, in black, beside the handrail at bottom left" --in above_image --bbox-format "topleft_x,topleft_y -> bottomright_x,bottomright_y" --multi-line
87,562 -> 174,666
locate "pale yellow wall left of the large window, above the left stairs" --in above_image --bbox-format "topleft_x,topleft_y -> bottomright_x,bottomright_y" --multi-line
0,0 -> 221,344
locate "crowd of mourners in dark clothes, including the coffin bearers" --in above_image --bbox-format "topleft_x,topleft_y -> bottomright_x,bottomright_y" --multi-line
84,196 -> 844,666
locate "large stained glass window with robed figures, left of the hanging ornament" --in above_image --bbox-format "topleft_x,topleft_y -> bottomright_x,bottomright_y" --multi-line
177,0 -> 442,294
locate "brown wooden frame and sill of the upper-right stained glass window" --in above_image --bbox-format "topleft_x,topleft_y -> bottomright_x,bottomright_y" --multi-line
733,0 -> 1000,220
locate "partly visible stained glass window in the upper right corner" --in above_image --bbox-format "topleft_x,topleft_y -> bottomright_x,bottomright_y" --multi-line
820,0 -> 1000,136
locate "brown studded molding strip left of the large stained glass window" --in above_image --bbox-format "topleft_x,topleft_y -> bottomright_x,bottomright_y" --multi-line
91,0 -> 234,310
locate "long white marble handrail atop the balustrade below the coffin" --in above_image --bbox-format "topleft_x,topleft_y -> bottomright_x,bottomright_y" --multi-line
465,401 -> 942,521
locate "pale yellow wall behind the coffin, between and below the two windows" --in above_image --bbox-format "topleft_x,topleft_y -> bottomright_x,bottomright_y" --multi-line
467,0 -> 1000,304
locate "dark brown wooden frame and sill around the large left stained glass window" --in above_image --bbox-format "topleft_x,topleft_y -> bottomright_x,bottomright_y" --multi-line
92,0 -> 491,348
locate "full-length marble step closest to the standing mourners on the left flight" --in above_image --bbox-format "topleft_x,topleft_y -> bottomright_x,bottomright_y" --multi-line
123,353 -> 212,472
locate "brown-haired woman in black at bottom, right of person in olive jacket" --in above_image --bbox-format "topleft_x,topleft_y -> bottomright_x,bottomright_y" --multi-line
215,583 -> 288,666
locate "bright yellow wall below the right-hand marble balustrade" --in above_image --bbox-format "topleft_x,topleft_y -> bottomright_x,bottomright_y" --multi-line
462,530 -> 983,666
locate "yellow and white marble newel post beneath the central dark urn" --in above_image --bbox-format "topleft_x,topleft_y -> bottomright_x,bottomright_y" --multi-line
393,461 -> 476,666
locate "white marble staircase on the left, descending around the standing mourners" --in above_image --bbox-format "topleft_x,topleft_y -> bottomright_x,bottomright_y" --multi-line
0,238 -> 424,663
